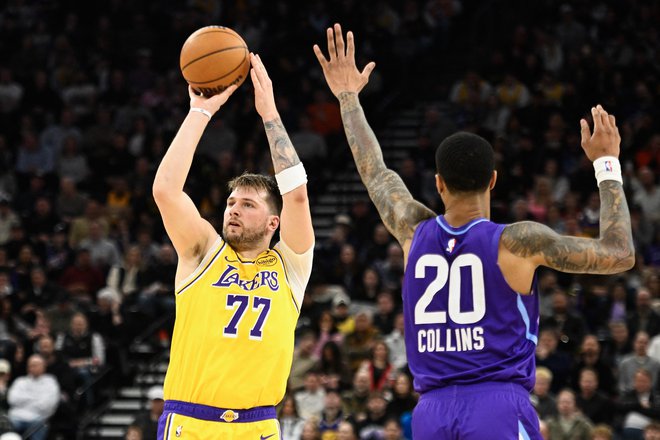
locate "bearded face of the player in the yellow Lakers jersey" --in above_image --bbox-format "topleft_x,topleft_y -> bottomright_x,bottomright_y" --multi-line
222,188 -> 279,251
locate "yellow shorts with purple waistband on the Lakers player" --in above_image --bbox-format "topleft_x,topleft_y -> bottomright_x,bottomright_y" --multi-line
158,400 -> 281,440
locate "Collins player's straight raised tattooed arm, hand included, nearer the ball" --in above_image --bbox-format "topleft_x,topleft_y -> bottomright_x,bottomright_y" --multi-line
314,24 -> 435,246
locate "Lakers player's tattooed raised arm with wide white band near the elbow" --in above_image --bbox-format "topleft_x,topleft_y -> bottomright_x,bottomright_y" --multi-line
250,54 -> 314,254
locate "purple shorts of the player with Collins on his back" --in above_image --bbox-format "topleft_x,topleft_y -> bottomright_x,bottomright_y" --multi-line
412,382 -> 542,440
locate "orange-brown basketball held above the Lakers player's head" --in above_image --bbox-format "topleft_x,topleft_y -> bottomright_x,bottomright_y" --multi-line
179,26 -> 250,96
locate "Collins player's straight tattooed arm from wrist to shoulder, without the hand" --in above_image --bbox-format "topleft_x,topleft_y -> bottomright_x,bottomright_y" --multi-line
338,92 -> 435,243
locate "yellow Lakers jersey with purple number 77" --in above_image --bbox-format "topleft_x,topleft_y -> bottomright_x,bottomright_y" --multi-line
164,239 -> 299,409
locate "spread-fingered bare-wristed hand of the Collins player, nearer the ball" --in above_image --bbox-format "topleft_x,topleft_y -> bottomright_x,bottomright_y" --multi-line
314,24 -> 376,97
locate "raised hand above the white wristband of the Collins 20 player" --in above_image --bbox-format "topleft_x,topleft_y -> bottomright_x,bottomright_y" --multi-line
580,104 -> 621,162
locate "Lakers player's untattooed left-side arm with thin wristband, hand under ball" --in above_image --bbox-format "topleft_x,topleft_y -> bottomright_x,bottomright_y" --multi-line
153,86 -> 236,258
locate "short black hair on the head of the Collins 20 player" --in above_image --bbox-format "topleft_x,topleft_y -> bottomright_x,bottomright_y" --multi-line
435,131 -> 495,192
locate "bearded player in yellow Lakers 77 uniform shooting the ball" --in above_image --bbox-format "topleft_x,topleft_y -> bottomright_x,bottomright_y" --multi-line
153,54 -> 314,440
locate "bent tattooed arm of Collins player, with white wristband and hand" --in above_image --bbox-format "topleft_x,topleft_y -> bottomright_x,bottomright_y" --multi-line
500,105 -> 635,274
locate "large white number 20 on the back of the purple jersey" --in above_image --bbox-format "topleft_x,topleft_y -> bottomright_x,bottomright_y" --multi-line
415,254 -> 486,324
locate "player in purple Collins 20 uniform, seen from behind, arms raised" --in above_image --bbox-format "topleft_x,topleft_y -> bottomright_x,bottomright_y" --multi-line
314,25 -> 634,440
